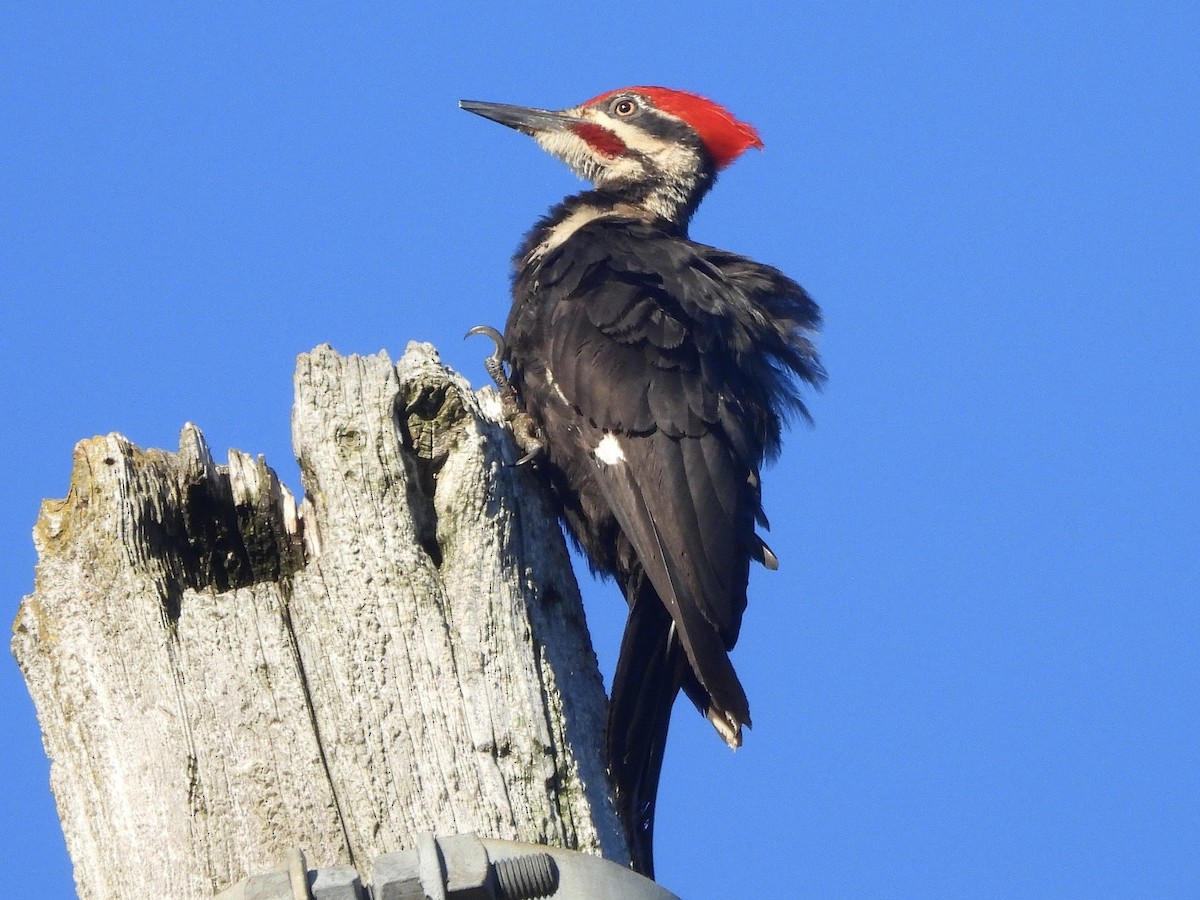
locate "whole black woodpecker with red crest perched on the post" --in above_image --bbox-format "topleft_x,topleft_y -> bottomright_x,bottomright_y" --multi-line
460,88 -> 824,877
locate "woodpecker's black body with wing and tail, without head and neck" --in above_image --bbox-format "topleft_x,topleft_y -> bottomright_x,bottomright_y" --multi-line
508,218 -> 823,874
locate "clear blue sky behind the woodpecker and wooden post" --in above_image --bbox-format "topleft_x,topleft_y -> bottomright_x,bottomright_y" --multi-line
0,2 -> 1200,898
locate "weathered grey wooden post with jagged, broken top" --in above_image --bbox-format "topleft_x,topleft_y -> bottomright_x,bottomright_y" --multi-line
13,344 -> 626,899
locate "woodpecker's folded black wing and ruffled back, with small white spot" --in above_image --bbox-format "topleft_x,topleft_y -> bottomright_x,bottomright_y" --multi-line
512,218 -> 820,739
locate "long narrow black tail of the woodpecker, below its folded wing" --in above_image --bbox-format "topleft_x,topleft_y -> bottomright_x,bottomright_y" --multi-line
608,580 -> 698,878
